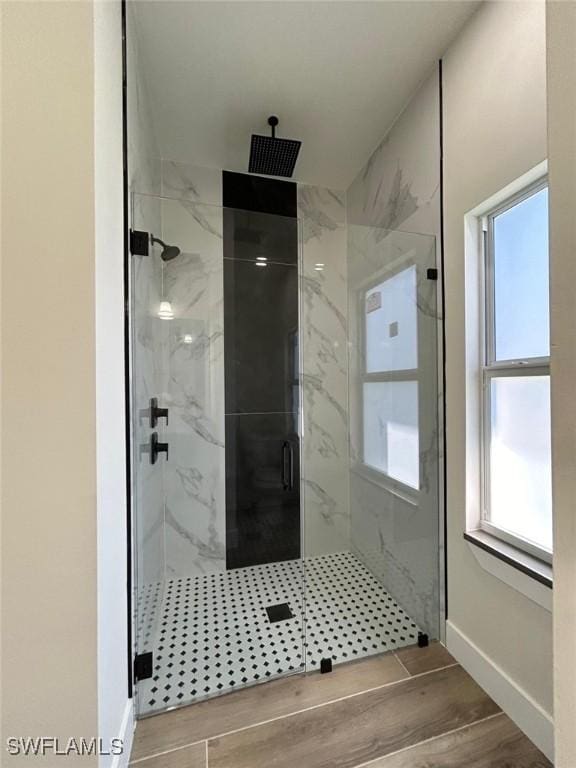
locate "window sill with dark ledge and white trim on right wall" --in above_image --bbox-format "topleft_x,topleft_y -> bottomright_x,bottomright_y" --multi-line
464,530 -> 553,611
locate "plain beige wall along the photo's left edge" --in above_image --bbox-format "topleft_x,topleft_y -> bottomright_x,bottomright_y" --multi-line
1,2 -> 98,766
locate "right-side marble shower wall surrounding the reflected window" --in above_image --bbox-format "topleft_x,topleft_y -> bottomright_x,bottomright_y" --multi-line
347,72 -> 442,635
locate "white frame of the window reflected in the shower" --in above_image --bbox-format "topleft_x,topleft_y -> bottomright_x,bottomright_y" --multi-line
356,256 -> 422,505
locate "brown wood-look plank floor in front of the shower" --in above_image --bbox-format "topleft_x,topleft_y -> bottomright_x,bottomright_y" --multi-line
131,643 -> 551,768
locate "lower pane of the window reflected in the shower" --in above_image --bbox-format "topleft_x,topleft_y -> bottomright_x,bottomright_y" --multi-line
364,381 -> 419,488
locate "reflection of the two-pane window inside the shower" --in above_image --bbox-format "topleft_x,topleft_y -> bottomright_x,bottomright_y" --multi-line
361,265 -> 420,490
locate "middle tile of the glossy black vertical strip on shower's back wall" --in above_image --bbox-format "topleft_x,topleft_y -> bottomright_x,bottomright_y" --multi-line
224,260 -> 298,413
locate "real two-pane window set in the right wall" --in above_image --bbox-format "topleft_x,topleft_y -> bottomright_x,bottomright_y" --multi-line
481,181 -> 552,560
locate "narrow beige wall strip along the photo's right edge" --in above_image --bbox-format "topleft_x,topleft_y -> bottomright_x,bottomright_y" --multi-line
546,0 -> 576,768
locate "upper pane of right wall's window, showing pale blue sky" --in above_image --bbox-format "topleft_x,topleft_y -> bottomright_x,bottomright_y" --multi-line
494,189 -> 550,360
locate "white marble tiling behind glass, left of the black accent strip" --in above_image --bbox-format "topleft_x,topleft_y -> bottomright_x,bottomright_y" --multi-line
162,192 -> 226,578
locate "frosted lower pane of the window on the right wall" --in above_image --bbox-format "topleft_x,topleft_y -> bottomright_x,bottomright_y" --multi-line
490,376 -> 552,550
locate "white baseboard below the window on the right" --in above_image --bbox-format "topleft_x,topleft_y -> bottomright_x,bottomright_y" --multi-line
446,621 -> 554,763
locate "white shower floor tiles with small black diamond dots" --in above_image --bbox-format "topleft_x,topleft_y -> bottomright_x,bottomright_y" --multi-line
138,552 -> 419,715
